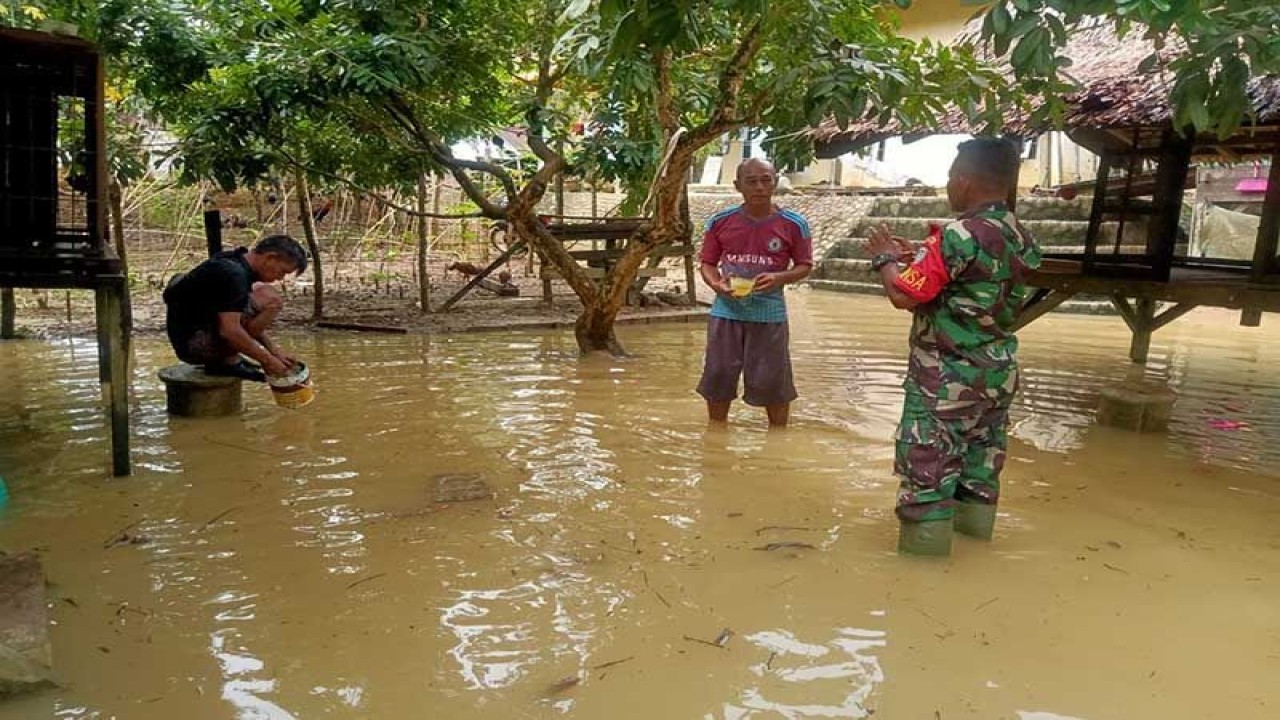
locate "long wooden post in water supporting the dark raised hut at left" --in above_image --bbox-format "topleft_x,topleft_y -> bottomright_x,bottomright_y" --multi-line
93,277 -> 132,477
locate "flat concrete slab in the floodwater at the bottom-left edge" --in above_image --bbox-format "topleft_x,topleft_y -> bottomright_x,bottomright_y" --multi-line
0,553 -> 52,697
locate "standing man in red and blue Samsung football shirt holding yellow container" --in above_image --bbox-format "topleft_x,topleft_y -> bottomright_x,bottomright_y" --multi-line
698,158 -> 813,427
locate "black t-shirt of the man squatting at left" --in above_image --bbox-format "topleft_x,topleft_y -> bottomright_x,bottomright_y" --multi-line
164,247 -> 253,342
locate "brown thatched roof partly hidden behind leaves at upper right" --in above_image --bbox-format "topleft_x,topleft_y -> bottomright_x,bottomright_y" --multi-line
810,18 -> 1280,158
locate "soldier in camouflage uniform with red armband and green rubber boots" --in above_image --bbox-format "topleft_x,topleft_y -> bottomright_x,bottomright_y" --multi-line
868,138 -> 1041,555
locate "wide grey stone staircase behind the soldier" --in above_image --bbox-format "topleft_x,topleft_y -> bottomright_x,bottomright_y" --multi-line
809,197 -> 1146,314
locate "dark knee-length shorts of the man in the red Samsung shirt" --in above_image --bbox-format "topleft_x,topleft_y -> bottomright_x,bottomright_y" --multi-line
698,318 -> 796,407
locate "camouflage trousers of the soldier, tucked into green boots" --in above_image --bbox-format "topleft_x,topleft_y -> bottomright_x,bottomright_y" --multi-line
893,372 -> 1016,523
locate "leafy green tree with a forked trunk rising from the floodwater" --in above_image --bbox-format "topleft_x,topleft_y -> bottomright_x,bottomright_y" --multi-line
15,0 -> 1014,352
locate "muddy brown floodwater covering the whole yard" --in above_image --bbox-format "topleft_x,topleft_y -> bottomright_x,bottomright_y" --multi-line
0,291 -> 1280,720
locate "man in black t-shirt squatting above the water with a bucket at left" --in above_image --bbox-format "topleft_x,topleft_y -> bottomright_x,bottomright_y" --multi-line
164,234 -> 307,382
